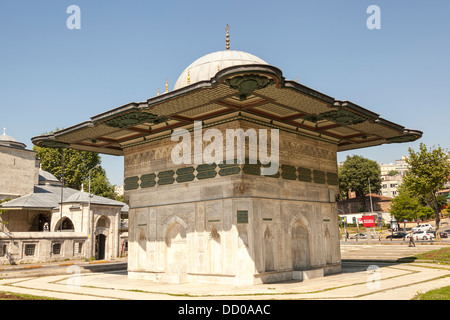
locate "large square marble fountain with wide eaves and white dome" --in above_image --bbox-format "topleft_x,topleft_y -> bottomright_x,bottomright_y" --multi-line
32,32 -> 422,285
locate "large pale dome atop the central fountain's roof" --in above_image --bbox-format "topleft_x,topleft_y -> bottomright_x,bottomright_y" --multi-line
174,50 -> 268,90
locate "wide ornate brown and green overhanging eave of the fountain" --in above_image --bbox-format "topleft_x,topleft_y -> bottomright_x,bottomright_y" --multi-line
32,65 -> 422,155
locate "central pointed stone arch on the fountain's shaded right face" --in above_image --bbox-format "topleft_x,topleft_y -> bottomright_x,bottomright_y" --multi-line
289,214 -> 312,270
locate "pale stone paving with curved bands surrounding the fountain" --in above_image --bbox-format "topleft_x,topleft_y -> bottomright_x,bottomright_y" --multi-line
0,243 -> 450,300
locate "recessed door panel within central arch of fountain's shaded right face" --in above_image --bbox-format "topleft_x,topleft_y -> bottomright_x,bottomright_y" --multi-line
291,219 -> 311,270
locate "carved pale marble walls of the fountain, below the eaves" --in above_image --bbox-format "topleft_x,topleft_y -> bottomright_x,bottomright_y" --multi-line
125,121 -> 340,284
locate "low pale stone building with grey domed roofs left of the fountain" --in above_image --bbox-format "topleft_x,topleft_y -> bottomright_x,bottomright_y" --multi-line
0,131 -> 128,265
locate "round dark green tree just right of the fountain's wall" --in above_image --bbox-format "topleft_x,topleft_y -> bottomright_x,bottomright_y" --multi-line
339,155 -> 381,211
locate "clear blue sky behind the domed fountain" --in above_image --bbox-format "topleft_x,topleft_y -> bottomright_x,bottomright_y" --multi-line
0,0 -> 450,185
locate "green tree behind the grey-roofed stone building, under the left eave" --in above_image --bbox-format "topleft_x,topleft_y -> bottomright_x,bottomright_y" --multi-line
33,146 -> 114,199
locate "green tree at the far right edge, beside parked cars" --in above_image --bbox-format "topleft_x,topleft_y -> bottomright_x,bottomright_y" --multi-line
403,143 -> 450,241
